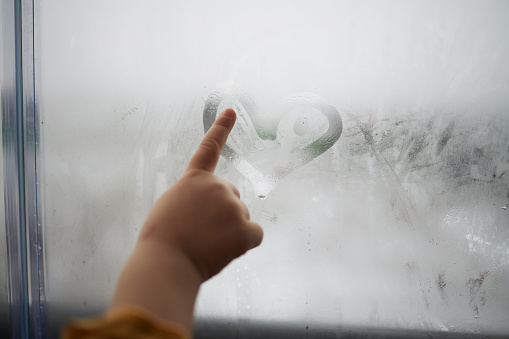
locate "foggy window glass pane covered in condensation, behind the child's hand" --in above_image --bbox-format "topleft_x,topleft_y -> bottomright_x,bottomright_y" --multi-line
37,0 -> 509,337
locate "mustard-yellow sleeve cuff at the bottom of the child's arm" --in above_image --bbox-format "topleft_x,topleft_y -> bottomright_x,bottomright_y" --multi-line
62,307 -> 191,339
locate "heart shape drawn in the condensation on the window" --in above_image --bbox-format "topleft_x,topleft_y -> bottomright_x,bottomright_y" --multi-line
203,83 -> 343,198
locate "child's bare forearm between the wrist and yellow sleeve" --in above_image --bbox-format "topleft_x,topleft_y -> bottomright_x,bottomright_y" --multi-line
110,239 -> 202,331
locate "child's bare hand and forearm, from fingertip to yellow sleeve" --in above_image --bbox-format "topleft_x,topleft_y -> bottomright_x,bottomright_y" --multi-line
110,109 -> 263,331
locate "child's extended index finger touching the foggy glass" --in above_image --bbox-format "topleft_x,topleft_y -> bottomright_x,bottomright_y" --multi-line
187,108 -> 237,173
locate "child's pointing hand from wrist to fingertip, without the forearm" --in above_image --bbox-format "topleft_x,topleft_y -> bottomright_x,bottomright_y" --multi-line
140,109 -> 263,281
